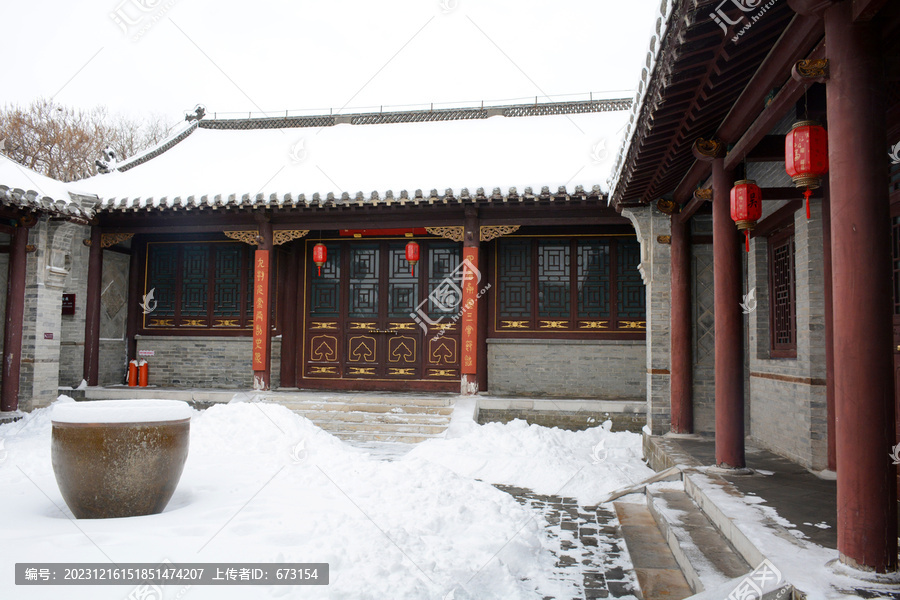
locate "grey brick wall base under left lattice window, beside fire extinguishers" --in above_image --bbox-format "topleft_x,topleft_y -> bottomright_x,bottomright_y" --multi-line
137,335 -> 281,389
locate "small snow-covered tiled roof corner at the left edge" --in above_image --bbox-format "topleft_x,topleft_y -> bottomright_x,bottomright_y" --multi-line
0,154 -> 89,218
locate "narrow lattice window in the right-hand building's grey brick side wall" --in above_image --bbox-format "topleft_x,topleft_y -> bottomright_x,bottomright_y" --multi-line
769,227 -> 797,358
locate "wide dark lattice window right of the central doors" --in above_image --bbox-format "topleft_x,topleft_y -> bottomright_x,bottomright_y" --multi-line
494,237 -> 646,335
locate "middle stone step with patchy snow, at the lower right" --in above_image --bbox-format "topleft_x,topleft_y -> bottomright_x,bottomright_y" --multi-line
647,489 -> 753,593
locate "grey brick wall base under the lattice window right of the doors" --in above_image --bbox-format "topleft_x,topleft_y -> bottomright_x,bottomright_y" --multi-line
488,339 -> 647,399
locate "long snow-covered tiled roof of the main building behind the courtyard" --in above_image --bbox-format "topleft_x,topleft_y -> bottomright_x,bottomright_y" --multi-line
69,100 -> 628,210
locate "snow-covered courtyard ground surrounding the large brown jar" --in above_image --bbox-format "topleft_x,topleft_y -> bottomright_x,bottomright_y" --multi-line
0,397 -> 651,600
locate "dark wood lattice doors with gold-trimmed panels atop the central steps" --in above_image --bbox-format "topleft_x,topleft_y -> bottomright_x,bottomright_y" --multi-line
304,240 -> 459,389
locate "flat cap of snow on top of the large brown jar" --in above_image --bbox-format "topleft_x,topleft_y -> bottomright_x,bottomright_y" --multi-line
50,400 -> 193,423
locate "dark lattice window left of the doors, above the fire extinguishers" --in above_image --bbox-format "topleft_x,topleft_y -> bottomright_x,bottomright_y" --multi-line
143,242 -> 255,330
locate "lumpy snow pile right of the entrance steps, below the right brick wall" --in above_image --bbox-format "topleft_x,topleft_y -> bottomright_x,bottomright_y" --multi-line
406,419 -> 653,506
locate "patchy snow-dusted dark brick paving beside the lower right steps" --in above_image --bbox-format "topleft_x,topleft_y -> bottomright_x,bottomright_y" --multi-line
495,485 -> 640,600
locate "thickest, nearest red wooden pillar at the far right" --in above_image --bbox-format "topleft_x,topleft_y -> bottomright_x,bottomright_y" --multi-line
825,2 -> 897,572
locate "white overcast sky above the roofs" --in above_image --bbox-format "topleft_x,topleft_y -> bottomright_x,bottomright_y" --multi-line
0,0 -> 660,125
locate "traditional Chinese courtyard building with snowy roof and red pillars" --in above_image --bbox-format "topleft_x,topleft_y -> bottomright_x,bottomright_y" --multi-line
0,0 -> 900,571
